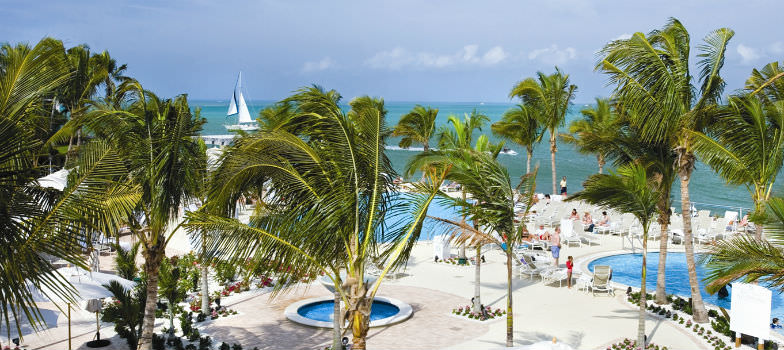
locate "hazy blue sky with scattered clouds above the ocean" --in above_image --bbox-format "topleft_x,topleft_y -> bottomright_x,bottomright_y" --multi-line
0,0 -> 784,102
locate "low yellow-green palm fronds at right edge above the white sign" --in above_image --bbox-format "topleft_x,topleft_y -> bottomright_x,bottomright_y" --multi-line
703,197 -> 784,293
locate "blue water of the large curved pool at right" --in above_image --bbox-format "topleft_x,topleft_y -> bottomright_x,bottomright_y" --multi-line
588,253 -> 784,318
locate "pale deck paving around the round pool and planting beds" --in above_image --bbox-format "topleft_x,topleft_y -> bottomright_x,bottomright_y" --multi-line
9,232 -> 728,349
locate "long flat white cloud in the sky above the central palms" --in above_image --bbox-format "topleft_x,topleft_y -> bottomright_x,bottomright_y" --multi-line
365,44 -> 509,70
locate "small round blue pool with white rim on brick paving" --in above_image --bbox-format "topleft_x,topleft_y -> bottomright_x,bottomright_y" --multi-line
284,297 -> 413,328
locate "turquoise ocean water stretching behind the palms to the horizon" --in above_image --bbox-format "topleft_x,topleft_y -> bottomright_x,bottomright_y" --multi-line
190,100 -> 764,215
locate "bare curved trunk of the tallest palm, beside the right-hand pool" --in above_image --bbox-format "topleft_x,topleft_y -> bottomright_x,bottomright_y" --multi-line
679,172 -> 708,323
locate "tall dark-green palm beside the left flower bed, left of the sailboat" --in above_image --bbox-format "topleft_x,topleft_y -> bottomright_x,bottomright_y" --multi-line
69,81 -> 206,349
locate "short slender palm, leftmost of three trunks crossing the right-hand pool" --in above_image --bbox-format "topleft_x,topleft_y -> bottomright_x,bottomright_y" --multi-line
568,165 -> 661,348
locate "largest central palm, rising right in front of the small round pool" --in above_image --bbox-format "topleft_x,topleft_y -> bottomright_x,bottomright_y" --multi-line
186,87 -> 441,349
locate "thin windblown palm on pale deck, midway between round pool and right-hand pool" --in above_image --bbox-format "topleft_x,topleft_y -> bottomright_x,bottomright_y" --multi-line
406,147 -> 536,347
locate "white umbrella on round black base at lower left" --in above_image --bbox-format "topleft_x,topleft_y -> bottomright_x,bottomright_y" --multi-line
31,267 -> 136,350
